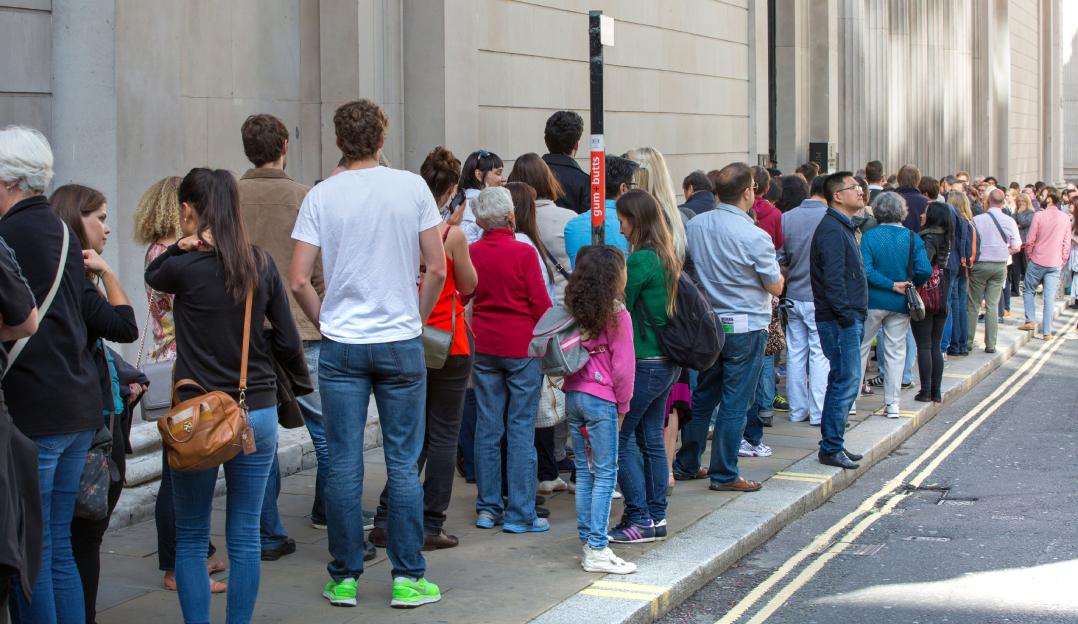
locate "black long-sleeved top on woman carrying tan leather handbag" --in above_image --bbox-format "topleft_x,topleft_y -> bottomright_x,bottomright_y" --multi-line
146,245 -> 303,410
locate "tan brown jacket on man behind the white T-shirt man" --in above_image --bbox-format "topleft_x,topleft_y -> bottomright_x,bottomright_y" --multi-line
238,167 -> 326,341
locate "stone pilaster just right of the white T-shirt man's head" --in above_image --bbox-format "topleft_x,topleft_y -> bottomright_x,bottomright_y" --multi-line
403,0 -> 479,171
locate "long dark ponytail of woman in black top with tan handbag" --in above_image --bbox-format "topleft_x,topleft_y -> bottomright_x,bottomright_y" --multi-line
177,168 -> 266,305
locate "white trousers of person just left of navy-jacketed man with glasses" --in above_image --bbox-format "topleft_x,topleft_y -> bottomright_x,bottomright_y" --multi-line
786,301 -> 831,424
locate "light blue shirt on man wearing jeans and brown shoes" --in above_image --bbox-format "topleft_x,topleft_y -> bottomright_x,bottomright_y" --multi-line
686,204 -> 782,333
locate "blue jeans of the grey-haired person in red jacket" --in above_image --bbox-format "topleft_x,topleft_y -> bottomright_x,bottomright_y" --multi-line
472,353 -> 543,526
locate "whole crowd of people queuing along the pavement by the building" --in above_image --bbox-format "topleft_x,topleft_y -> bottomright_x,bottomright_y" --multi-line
0,99 -> 1078,624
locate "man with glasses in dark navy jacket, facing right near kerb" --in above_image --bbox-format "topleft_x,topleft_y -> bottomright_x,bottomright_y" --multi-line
810,171 -> 869,469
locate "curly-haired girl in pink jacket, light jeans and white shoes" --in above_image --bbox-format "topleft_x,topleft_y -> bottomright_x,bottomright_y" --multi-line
562,245 -> 636,574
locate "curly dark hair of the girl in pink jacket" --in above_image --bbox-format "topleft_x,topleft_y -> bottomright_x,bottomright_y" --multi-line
565,245 -> 625,339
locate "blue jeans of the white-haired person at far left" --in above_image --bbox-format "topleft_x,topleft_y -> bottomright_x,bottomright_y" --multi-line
11,431 -> 93,624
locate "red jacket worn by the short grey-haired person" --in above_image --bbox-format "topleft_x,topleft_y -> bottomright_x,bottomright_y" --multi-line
468,228 -> 551,358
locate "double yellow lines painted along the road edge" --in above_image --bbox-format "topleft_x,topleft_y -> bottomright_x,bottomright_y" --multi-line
716,318 -> 1075,624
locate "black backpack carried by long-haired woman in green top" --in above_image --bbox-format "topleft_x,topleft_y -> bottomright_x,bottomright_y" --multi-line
636,272 -> 727,371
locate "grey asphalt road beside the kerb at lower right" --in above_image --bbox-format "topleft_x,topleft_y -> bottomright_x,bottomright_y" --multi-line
661,327 -> 1078,624
